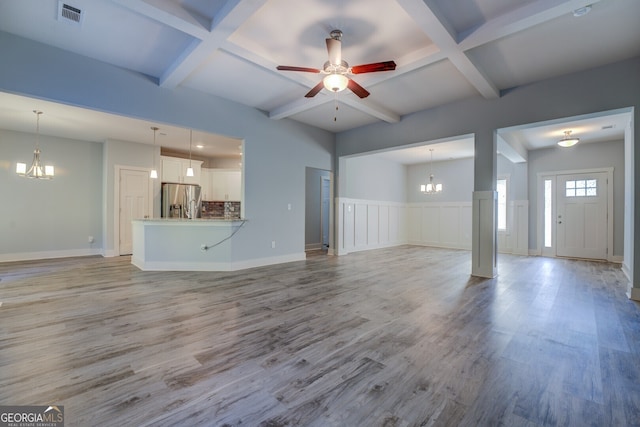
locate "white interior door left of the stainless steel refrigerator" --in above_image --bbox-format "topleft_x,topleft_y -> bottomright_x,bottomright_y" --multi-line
119,169 -> 152,255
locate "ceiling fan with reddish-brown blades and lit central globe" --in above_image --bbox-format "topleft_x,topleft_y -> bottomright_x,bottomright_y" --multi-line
277,30 -> 396,98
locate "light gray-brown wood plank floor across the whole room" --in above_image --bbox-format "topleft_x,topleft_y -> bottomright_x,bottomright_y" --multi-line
0,246 -> 640,426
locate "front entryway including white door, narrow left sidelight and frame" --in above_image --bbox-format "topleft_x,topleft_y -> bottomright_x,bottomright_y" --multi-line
540,169 -> 613,260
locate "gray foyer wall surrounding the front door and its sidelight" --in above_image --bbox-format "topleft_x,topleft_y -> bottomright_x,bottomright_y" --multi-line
528,141 -> 624,256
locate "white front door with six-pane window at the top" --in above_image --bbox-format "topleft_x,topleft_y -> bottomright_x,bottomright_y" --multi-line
556,172 -> 608,259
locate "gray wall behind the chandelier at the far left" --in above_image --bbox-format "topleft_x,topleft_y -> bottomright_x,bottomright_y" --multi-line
0,129 -> 103,258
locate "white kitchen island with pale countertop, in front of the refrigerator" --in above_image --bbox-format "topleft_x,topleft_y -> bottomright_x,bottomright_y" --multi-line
131,218 -> 247,271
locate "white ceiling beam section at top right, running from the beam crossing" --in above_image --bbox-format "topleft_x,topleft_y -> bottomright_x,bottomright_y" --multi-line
459,0 -> 600,51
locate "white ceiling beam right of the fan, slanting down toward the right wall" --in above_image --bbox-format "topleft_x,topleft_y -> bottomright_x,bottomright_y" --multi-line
397,0 -> 500,98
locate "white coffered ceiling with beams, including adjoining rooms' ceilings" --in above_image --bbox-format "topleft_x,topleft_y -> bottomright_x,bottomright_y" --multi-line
0,0 -> 640,161
